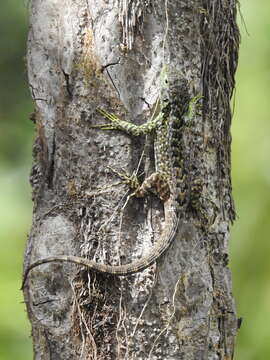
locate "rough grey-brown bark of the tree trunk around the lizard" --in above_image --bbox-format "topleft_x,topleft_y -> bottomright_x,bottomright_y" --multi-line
24,0 -> 239,360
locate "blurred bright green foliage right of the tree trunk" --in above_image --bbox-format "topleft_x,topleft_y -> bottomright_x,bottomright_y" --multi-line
231,0 -> 270,360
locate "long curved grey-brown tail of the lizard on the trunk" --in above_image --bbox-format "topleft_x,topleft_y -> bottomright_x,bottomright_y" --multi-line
21,200 -> 179,289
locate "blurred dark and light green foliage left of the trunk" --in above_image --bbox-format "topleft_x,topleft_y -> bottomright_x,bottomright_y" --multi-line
0,0 -> 33,360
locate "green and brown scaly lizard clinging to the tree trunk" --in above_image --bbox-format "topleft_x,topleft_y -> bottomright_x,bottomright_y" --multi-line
22,66 -> 193,288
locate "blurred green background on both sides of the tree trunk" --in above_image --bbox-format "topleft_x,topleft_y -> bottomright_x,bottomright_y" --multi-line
0,0 -> 270,360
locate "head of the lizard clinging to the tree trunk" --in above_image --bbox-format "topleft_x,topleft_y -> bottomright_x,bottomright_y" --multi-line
160,65 -> 190,113
